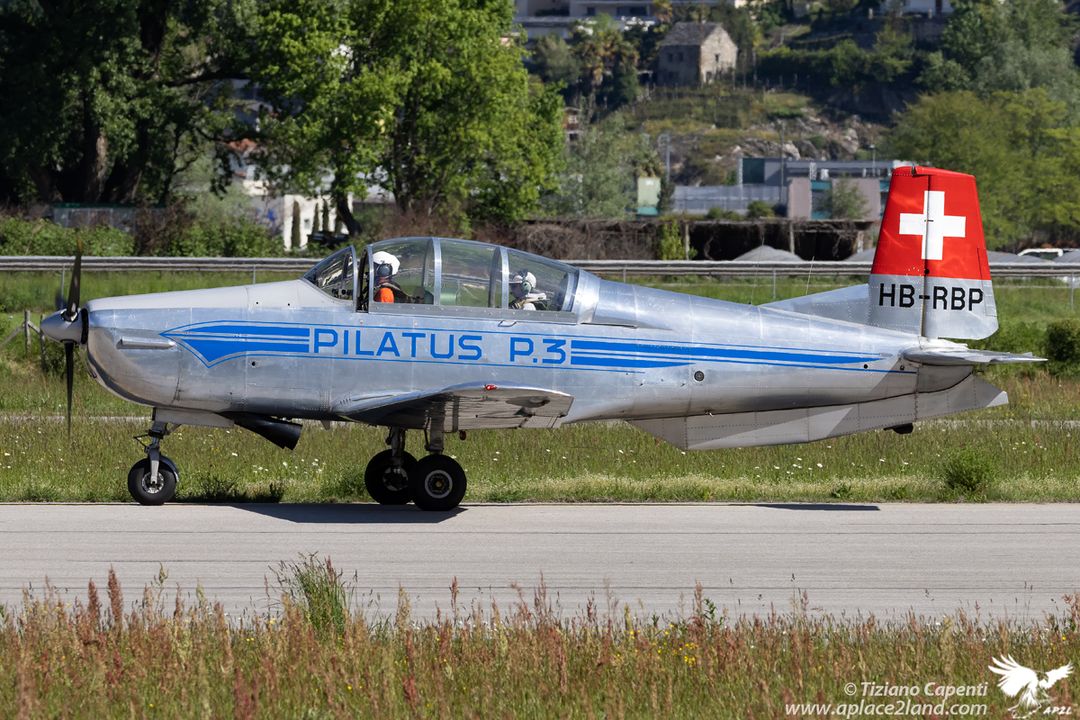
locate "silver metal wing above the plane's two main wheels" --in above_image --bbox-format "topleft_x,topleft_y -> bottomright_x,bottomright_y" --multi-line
335,384 -> 573,433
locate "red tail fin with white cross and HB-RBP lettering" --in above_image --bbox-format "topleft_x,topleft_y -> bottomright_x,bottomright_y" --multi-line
869,167 -> 998,339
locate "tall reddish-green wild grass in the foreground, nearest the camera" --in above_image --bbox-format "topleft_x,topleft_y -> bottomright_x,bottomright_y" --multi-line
0,558 -> 1080,719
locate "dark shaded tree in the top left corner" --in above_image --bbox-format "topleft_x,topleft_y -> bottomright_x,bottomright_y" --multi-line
0,0 -> 239,203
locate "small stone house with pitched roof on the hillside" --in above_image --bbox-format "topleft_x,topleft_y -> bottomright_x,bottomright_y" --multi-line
656,23 -> 739,85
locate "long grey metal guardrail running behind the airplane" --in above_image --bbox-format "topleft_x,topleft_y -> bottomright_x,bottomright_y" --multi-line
0,256 -> 1080,277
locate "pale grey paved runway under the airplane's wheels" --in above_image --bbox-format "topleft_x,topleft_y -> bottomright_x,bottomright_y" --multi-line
0,504 -> 1080,621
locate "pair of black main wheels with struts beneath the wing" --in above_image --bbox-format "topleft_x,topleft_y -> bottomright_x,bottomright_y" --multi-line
364,427 -> 467,511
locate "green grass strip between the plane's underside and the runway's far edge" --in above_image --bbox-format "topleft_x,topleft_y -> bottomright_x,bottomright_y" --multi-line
0,403 -> 1080,502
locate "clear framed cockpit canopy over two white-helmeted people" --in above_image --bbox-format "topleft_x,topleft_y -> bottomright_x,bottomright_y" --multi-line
303,237 -> 580,312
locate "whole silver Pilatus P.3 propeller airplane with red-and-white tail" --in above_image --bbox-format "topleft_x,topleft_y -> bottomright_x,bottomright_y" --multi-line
42,166 -> 1041,511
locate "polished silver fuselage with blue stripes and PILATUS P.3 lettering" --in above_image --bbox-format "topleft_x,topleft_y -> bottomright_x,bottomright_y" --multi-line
87,268 -> 954,431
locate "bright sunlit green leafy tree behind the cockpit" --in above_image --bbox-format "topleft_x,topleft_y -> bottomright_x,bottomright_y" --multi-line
249,0 -> 563,233
